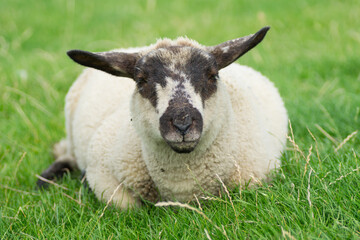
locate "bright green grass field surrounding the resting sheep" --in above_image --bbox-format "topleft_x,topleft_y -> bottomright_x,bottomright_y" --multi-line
0,0 -> 360,239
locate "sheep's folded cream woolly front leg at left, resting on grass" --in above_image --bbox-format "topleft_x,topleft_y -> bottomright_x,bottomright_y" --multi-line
86,167 -> 141,210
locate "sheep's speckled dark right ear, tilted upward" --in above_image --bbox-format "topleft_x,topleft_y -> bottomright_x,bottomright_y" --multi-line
207,27 -> 270,69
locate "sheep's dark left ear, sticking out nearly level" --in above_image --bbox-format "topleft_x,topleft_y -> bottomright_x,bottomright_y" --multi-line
67,50 -> 139,78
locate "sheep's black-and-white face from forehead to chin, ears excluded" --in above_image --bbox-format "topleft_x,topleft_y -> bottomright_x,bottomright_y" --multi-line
135,47 -> 218,153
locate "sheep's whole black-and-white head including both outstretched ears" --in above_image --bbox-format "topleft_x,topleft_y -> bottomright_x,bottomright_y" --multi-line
68,27 -> 269,153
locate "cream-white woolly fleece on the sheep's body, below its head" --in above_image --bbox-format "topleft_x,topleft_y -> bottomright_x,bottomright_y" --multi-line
61,59 -> 288,209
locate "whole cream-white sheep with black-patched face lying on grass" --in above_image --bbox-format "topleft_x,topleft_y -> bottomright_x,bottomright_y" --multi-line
38,27 -> 288,209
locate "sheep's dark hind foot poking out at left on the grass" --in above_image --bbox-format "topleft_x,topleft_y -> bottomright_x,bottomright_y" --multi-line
36,162 -> 74,189
